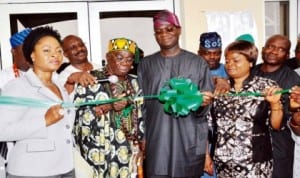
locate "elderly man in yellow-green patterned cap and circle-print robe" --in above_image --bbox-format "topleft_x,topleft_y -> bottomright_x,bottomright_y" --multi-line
74,38 -> 143,178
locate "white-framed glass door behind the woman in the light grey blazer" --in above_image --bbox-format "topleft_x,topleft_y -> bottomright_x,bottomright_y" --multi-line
0,2 -> 90,68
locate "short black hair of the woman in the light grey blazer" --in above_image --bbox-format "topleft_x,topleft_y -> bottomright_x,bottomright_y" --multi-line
22,26 -> 62,64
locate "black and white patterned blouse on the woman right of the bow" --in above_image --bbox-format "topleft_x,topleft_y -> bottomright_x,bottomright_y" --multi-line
208,76 -> 277,178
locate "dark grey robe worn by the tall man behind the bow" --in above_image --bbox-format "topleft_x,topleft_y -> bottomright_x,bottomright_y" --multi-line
138,50 -> 213,177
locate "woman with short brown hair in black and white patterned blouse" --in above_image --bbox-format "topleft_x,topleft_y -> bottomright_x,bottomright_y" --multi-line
209,40 -> 283,178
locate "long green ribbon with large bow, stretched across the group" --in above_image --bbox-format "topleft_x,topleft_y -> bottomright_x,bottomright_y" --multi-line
0,78 -> 290,116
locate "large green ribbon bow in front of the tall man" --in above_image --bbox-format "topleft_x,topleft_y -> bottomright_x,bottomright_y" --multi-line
158,78 -> 203,116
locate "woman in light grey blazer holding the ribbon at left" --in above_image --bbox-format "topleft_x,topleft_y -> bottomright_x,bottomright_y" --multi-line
0,26 -> 75,178
